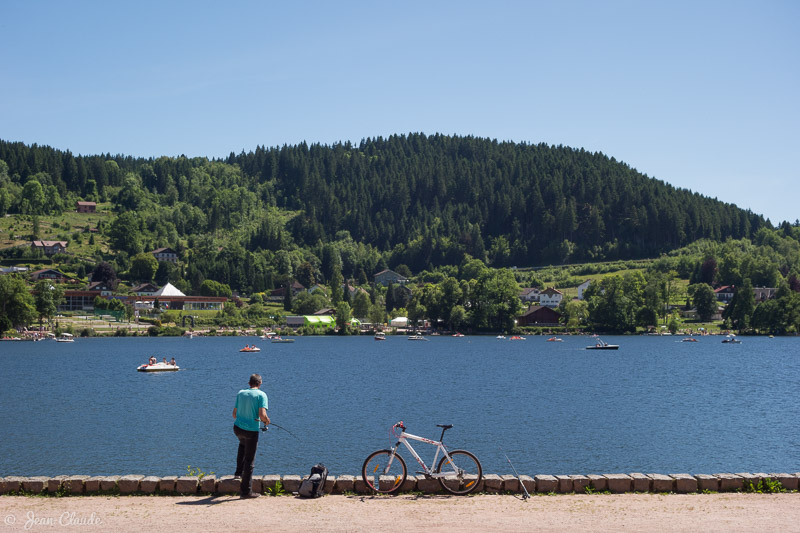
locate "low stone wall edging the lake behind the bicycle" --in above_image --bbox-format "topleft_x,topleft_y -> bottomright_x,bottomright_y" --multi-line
0,472 -> 800,495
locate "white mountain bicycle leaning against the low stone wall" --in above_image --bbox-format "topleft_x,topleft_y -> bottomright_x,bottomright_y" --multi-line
361,420 -> 483,495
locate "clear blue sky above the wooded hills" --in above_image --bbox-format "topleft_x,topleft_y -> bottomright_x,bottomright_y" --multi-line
0,0 -> 800,223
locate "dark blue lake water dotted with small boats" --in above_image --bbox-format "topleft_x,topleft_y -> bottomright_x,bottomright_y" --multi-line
0,336 -> 800,476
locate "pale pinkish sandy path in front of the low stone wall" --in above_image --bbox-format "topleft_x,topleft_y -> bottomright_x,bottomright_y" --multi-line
0,493 -> 800,533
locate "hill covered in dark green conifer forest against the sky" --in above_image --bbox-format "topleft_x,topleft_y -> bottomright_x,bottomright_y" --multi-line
0,134 -> 767,271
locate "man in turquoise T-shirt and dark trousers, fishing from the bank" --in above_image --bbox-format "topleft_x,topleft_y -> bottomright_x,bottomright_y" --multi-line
233,374 -> 269,498
